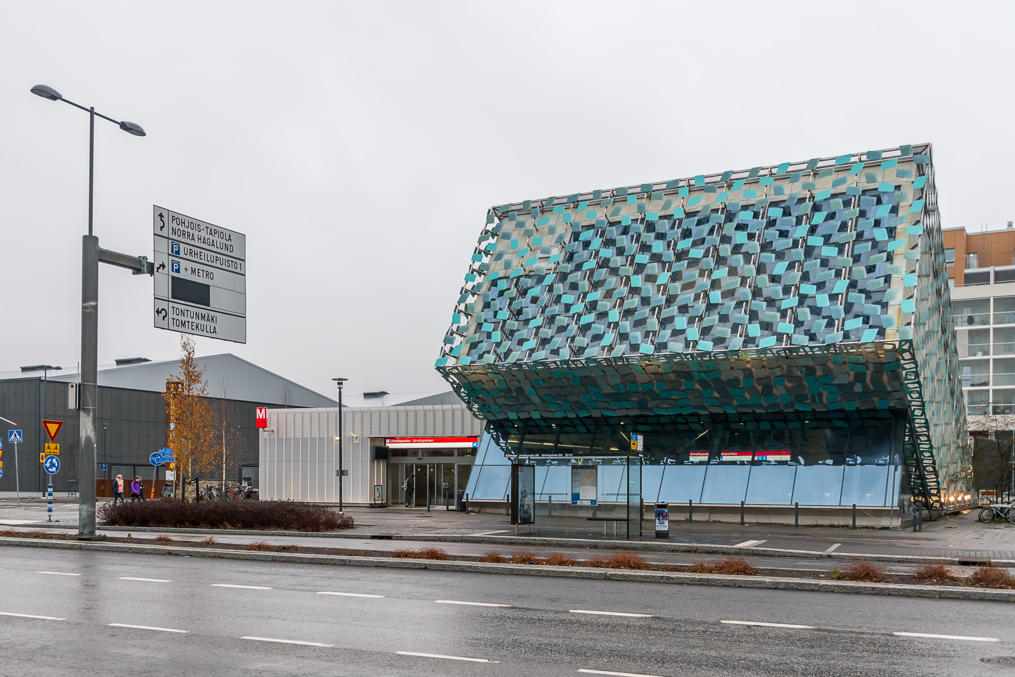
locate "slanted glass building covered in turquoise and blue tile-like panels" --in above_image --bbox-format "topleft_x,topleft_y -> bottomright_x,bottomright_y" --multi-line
436,144 -> 972,522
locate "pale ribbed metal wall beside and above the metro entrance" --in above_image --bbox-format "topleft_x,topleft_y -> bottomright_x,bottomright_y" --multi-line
259,405 -> 482,503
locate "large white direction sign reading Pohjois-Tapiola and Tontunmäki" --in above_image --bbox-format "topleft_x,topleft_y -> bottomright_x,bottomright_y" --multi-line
152,205 -> 247,343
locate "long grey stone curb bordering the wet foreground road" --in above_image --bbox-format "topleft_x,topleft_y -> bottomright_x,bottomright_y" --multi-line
0,537 -> 1015,602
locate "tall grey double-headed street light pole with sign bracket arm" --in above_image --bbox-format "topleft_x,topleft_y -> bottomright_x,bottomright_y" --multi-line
31,84 -> 151,539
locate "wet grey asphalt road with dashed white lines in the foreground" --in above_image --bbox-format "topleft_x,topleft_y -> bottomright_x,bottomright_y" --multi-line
0,547 -> 1015,677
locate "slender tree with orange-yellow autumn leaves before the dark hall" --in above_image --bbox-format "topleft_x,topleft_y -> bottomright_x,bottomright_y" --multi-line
162,335 -> 218,496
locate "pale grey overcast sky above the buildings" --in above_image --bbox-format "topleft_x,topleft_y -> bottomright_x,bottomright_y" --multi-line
0,0 -> 1015,396
